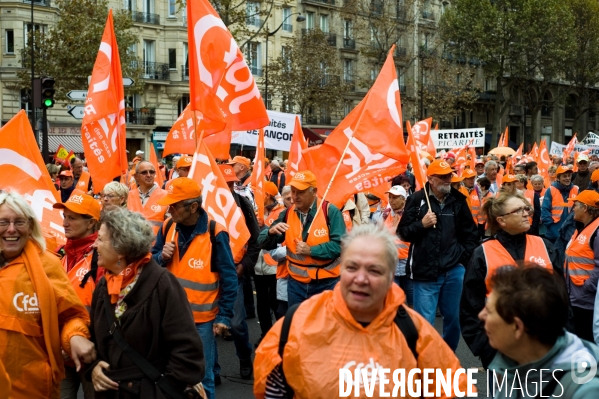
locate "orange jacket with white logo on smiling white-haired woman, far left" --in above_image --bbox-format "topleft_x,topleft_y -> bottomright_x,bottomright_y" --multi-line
0,240 -> 89,399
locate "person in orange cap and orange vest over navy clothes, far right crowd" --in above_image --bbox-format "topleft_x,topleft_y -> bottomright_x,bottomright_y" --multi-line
541,166 -> 578,243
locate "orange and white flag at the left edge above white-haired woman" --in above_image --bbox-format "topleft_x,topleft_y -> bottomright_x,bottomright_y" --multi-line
0,110 -> 66,247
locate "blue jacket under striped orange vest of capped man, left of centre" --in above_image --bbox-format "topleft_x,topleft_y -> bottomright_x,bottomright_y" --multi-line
152,208 -> 237,327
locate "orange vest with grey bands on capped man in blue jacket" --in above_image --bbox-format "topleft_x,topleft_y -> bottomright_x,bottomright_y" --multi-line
165,217 -> 225,323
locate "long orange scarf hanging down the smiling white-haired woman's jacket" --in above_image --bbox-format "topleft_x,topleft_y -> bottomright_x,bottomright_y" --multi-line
22,240 -> 64,384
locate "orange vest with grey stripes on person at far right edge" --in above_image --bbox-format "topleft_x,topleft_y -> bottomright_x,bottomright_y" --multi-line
566,218 -> 599,286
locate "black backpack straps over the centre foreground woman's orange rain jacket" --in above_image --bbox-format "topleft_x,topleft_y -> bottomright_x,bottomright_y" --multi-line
279,304 -> 418,399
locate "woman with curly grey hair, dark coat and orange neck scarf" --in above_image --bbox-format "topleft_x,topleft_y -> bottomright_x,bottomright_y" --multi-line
89,208 -> 204,399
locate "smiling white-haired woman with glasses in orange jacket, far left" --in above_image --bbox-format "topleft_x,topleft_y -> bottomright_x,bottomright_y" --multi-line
0,192 -> 95,398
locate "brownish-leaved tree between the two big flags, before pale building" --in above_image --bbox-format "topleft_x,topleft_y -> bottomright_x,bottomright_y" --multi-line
268,29 -> 348,124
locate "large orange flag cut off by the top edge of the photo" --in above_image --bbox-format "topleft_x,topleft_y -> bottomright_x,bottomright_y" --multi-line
187,0 -> 270,135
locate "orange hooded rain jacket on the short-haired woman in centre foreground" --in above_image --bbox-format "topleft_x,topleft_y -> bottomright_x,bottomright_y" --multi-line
254,284 -> 472,399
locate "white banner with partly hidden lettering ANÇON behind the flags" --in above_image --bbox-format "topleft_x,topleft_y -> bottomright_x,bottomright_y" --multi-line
231,111 -> 296,151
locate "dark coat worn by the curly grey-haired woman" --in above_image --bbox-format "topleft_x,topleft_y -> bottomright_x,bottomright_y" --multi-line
88,260 -> 205,399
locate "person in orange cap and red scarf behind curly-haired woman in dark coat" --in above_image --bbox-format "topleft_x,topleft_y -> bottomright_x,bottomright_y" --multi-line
53,190 -> 104,399
